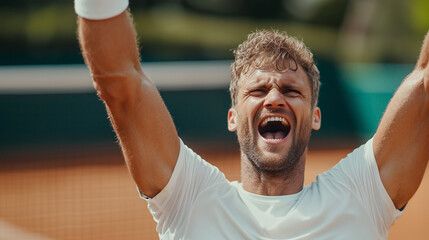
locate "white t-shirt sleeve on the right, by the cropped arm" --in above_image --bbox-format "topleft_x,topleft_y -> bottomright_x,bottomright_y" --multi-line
327,139 -> 402,235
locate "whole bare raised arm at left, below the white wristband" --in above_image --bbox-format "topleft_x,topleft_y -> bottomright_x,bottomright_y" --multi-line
78,8 -> 180,197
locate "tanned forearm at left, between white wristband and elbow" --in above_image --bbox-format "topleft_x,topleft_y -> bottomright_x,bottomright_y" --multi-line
78,11 -> 147,104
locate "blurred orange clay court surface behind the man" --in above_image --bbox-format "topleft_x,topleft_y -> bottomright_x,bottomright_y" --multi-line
0,144 -> 429,240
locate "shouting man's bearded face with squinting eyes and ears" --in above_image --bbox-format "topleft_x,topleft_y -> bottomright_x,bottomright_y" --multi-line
228,67 -> 321,172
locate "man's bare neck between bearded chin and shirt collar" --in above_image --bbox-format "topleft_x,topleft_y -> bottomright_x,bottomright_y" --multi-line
241,152 -> 307,196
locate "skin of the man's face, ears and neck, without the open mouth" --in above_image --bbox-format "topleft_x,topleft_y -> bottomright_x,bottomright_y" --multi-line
228,67 -> 321,196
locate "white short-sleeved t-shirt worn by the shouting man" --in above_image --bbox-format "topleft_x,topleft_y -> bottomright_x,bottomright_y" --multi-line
141,140 -> 401,240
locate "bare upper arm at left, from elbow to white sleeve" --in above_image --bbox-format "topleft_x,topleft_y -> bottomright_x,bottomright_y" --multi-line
105,74 -> 180,197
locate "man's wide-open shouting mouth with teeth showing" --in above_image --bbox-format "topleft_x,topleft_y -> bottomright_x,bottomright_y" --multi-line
258,117 -> 290,140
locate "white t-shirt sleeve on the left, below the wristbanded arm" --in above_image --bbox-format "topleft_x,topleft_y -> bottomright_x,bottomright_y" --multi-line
139,140 -> 227,238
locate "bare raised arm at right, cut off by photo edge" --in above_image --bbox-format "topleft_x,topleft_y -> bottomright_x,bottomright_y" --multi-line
373,31 -> 429,209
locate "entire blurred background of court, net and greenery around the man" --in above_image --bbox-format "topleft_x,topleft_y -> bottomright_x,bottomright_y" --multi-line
0,0 -> 429,239
